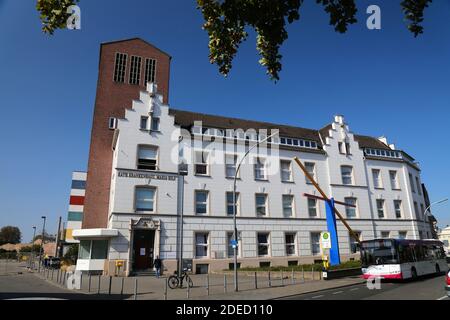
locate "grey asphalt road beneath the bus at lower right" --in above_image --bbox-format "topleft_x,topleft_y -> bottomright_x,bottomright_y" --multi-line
277,275 -> 450,300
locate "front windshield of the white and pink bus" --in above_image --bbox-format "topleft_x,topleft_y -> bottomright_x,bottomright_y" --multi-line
361,240 -> 399,267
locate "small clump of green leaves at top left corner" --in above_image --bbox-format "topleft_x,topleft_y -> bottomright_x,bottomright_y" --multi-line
36,0 -> 79,35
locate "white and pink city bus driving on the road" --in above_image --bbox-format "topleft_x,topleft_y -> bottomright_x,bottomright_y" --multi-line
360,239 -> 448,279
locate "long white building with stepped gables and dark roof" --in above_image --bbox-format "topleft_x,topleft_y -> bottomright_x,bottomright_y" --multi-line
74,84 -> 431,275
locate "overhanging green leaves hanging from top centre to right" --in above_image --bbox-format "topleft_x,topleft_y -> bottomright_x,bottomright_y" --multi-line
197,0 -> 432,81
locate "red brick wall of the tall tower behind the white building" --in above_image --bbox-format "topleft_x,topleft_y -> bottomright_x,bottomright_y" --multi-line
83,39 -> 170,229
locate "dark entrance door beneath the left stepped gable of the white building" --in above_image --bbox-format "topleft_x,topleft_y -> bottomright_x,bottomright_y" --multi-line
133,230 -> 155,270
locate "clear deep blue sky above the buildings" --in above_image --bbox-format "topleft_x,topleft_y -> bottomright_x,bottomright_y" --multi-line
0,0 -> 450,241
